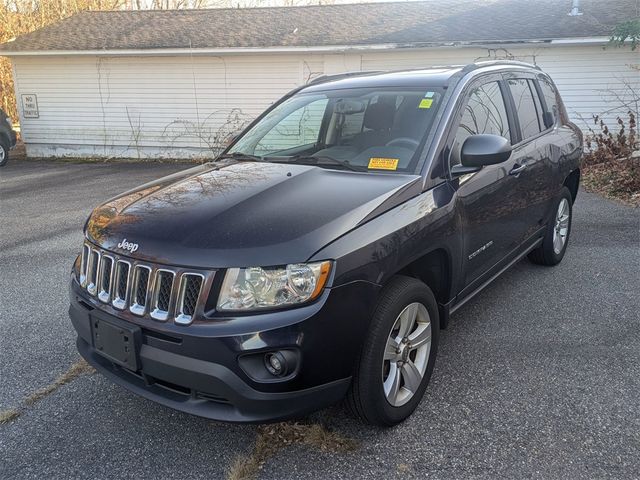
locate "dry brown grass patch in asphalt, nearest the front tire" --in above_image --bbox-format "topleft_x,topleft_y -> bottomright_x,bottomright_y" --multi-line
227,422 -> 358,480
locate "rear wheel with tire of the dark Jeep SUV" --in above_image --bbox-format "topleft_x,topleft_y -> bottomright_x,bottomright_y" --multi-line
529,187 -> 573,266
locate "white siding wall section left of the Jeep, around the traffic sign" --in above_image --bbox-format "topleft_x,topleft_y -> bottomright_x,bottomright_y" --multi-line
14,55 -> 322,157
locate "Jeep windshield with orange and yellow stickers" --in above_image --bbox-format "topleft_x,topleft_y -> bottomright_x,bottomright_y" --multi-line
227,88 -> 442,173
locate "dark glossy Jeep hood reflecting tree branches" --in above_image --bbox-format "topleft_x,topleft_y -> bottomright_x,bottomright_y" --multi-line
85,162 -> 421,268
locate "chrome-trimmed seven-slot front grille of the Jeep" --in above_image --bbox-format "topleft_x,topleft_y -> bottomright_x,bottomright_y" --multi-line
78,244 -> 213,325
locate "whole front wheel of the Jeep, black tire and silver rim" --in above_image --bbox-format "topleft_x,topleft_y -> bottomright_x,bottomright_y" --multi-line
347,276 -> 440,427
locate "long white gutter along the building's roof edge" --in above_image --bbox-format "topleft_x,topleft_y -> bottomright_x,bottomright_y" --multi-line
0,37 -> 609,57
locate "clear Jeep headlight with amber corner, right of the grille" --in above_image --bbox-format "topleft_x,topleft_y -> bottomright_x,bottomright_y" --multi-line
218,262 -> 331,311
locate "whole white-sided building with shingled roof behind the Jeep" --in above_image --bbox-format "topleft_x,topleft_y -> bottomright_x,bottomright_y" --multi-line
0,0 -> 640,157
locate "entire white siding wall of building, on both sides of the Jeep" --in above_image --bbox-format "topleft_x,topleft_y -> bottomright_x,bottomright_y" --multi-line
12,44 -> 640,158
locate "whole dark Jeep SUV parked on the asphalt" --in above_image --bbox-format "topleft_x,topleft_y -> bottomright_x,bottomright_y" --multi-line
70,62 -> 582,426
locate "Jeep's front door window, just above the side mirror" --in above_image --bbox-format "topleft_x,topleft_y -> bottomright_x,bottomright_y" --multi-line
450,82 -> 511,165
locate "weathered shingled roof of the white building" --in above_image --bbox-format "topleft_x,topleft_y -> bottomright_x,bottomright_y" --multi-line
0,0 -> 638,55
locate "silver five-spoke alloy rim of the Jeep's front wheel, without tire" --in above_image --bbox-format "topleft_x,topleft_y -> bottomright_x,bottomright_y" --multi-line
382,302 -> 431,407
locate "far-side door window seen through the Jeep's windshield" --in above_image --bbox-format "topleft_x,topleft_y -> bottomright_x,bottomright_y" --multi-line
254,98 -> 328,155
